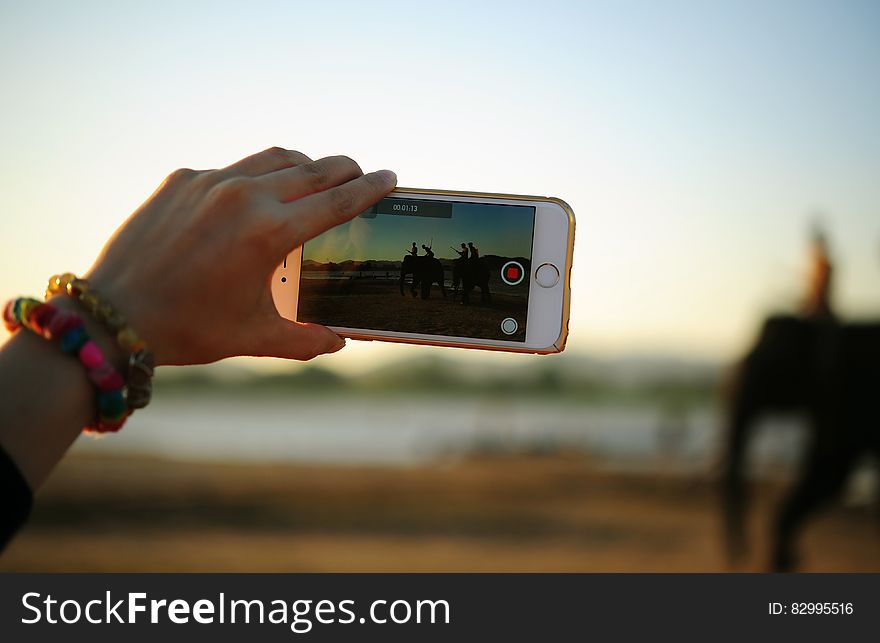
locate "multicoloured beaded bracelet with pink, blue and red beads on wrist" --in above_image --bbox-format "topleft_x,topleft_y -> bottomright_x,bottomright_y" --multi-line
3,297 -> 130,433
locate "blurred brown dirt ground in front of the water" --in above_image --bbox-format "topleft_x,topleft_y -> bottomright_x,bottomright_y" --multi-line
0,456 -> 880,572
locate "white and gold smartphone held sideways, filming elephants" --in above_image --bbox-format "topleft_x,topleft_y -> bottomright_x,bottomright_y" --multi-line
272,188 -> 575,353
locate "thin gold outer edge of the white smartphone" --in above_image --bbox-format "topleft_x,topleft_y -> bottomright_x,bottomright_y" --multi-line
338,187 -> 575,355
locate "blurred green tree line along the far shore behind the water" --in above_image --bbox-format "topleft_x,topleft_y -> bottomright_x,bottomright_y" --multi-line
156,357 -> 721,407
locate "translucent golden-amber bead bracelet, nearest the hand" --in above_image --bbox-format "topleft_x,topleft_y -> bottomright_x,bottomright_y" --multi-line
46,272 -> 155,411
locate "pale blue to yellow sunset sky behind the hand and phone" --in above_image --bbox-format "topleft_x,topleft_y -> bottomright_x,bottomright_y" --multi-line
0,0 -> 880,367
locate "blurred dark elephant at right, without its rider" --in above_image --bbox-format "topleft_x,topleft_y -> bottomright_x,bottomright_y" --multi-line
723,316 -> 880,571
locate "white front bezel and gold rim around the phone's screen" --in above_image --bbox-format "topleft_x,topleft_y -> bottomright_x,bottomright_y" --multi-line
271,188 -> 575,354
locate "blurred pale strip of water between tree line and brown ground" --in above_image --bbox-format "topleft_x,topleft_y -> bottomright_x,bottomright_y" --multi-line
74,395 -> 803,472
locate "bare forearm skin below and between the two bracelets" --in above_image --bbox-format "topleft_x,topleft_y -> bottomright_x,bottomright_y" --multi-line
0,297 -> 124,490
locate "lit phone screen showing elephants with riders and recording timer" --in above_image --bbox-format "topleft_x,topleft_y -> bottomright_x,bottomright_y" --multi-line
297,197 -> 535,342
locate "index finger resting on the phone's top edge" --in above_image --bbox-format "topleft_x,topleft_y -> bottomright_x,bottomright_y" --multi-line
284,170 -> 397,246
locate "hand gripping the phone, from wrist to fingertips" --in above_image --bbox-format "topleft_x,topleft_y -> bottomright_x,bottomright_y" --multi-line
86,147 -> 397,364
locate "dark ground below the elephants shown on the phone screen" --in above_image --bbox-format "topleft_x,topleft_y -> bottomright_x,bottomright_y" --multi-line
298,279 -> 528,341
